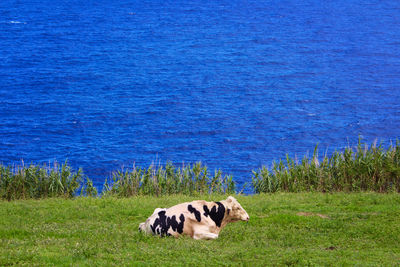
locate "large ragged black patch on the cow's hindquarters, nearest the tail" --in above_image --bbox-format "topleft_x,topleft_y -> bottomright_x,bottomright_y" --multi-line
150,211 -> 185,236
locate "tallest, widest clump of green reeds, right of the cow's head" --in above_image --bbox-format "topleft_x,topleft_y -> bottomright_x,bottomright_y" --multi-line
252,140 -> 400,193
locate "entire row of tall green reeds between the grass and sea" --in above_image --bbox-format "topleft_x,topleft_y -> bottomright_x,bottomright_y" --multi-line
0,141 -> 400,200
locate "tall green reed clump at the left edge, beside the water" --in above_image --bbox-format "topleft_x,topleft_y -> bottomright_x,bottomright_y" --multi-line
0,162 -> 97,200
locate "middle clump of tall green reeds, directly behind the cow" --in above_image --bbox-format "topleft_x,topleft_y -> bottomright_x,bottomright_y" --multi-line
102,162 -> 235,197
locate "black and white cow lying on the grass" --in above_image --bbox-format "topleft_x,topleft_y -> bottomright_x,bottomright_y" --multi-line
139,196 -> 249,239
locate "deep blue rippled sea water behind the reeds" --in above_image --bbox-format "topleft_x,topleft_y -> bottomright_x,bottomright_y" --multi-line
0,0 -> 400,189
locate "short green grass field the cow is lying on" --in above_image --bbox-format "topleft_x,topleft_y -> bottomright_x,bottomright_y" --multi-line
0,193 -> 400,266
